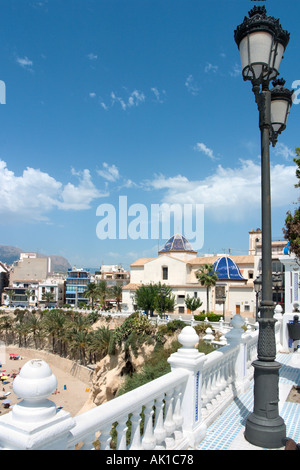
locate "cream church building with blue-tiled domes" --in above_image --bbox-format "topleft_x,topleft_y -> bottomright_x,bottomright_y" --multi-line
123,229 -> 286,318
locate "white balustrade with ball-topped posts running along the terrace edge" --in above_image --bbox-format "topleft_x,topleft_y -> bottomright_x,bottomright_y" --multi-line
0,315 -> 264,451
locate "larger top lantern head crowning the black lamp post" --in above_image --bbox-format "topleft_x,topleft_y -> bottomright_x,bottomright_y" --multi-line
234,6 -> 290,86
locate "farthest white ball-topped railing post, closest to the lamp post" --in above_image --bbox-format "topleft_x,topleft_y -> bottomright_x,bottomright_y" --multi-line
225,314 -> 250,391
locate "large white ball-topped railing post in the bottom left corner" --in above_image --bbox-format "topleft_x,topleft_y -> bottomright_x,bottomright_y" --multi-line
0,359 -> 75,450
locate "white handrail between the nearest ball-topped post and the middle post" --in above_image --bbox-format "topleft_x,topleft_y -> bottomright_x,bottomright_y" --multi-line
68,369 -> 189,447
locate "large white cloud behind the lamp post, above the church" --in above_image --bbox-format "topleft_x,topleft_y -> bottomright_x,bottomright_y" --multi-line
147,160 -> 296,221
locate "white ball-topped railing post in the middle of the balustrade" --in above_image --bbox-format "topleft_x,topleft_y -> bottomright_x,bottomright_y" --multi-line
168,326 -> 206,446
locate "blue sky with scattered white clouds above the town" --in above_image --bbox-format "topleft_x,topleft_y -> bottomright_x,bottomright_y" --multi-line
0,0 -> 300,267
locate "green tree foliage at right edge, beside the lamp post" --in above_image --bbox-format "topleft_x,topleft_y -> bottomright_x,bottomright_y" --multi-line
283,147 -> 300,260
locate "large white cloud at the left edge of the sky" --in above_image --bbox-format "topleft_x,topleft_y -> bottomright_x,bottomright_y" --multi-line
0,160 -> 107,222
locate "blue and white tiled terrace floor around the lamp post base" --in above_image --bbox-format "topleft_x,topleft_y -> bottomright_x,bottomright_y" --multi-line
196,353 -> 300,450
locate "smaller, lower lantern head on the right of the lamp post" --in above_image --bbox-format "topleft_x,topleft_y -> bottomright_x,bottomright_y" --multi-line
271,78 -> 294,147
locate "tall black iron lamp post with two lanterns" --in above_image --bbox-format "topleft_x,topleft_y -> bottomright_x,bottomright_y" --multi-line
234,6 -> 291,449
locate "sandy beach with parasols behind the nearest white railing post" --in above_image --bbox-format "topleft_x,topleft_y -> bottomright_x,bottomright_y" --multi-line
0,348 -> 90,416
